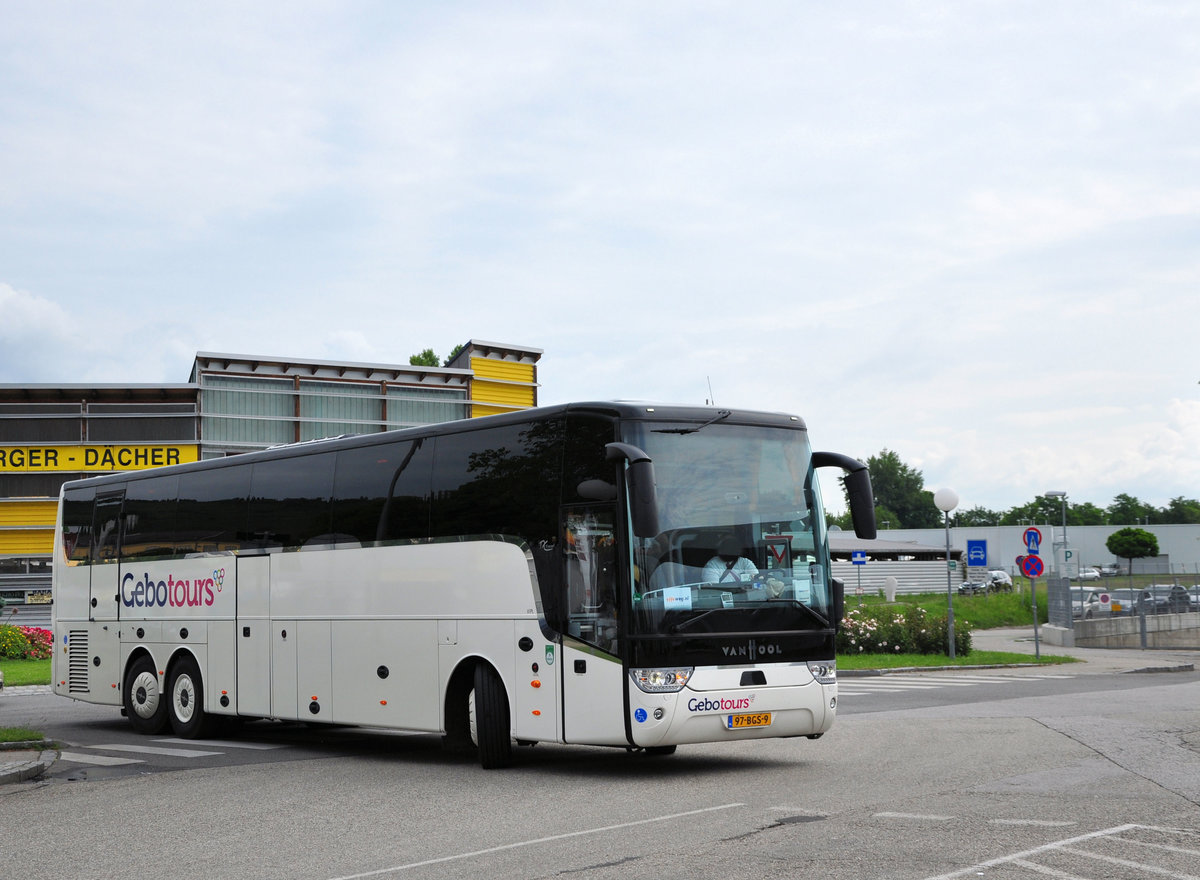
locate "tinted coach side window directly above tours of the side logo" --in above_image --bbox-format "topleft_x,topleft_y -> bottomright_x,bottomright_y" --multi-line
175,465 -> 250,552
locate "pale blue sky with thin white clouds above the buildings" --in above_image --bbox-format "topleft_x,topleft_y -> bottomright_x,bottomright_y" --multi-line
0,0 -> 1200,509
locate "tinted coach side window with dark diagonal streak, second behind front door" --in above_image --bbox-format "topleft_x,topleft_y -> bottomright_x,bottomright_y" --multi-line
334,438 -> 433,544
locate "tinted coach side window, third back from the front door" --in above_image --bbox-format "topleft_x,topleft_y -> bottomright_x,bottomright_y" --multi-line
244,453 -> 334,547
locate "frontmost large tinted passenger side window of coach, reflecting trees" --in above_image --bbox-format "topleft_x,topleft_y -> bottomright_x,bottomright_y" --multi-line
431,420 -> 563,546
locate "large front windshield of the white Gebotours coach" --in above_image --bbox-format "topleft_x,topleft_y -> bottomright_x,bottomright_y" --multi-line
626,423 -> 833,637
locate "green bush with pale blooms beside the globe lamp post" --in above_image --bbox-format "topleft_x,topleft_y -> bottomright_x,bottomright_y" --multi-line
838,605 -> 971,657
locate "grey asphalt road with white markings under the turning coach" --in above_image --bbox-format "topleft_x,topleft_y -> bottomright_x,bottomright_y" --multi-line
0,668 -> 1200,880
